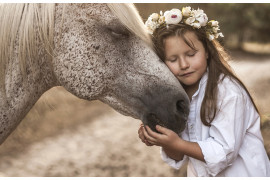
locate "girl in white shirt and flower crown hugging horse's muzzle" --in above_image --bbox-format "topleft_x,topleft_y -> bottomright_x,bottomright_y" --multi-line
138,7 -> 270,176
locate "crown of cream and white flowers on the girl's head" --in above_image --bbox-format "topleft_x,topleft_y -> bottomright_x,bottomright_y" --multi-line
145,6 -> 224,41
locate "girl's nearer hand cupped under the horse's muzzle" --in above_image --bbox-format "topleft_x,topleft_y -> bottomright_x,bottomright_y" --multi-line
142,125 -> 183,150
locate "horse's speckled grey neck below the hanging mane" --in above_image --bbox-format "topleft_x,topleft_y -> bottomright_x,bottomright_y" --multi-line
0,38 -> 57,144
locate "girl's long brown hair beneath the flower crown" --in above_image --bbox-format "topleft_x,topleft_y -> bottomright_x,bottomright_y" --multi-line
152,24 -> 258,126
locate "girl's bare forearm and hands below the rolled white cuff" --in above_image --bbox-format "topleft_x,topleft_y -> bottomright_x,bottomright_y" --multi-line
143,125 -> 205,162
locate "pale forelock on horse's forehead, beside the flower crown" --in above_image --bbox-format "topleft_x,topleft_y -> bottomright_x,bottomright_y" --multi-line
108,3 -> 152,47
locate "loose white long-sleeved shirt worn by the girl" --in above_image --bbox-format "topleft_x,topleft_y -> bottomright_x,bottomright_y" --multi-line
161,73 -> 270,177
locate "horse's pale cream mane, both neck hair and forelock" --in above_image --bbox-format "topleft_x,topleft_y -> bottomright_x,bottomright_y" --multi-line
0,3 -> 152,91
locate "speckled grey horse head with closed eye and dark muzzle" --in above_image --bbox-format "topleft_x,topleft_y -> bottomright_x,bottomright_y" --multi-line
53,4 -> 189,133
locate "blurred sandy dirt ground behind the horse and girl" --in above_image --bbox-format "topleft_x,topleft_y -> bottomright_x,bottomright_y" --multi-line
0,50 -> 270,177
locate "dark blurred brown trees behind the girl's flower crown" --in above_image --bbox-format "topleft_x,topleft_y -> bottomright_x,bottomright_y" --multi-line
135,3 -> 270,49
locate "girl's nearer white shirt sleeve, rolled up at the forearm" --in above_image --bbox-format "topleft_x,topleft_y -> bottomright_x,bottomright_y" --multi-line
197,94 -> 251,176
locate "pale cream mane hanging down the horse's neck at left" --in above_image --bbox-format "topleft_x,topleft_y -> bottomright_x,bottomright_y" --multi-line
0,3 -> 55,91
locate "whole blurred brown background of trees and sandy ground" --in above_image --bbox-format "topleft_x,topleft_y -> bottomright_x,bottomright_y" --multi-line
0,3 -> 270,177
